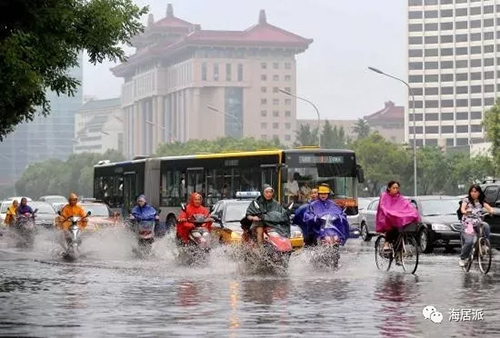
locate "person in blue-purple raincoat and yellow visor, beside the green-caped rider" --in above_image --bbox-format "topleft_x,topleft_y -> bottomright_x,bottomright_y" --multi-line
303,183 -> 349,245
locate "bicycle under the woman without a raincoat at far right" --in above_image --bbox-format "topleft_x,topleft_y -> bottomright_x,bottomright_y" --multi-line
462,211 -> 492,274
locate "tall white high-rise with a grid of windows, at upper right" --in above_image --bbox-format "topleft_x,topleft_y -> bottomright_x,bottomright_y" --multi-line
405,0 -> 500,147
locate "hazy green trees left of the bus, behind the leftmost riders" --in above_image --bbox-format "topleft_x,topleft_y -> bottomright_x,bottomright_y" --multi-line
15,150 -> 124,198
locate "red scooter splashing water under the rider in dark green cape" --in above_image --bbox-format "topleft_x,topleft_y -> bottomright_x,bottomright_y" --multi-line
241,201 -> 293,270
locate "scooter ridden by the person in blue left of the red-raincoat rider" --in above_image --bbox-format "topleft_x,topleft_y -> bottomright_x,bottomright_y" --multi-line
129,210 -> 161,256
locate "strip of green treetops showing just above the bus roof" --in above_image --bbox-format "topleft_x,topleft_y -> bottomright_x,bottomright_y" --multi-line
155,137 -> 283,156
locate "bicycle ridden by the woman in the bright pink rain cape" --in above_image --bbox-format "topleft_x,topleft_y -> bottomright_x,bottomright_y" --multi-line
375,224 -> 419,274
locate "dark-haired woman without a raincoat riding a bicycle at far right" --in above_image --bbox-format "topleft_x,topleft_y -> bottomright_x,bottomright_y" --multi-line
458,184 -> 494,266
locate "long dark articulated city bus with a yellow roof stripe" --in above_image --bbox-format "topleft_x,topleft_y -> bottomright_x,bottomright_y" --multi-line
94,147 -> 364,230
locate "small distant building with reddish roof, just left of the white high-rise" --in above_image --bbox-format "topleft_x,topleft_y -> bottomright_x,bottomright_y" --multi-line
364,101 -> 405,143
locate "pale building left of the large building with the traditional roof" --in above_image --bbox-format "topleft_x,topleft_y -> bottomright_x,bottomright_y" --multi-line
75,98 -> 123,154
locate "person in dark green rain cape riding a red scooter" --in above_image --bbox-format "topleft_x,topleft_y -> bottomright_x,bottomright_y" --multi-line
242,184 -> 290,245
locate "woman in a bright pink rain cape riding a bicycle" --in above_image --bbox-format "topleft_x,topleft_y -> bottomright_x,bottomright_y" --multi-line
375,181 -> 420,254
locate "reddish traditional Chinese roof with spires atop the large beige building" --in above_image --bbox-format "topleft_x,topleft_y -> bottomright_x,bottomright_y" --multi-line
112,4 -> 313,76
